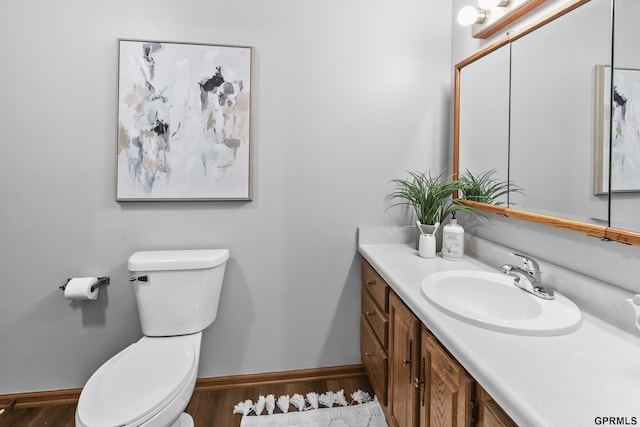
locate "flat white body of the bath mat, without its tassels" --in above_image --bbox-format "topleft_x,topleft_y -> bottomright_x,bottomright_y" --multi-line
240,400 -> 388,427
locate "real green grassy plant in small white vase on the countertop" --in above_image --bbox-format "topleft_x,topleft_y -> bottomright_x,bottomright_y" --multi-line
387,172 -> 475,251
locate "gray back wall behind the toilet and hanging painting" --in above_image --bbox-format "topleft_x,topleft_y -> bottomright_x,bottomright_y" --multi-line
0,0 -> 452,394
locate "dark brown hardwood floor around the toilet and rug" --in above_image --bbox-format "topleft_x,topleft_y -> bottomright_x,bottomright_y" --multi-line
0,369 -> 373,427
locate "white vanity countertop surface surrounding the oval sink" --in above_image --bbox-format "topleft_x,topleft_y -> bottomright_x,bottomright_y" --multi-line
358,243 -> 640,427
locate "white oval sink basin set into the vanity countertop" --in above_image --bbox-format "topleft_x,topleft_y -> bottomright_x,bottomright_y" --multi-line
421,270 -> 582,336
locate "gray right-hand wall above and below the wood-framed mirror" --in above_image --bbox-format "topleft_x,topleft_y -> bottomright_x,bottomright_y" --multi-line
451,0 -> 640,293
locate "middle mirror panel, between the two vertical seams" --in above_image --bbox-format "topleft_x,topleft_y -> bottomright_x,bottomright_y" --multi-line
509,0 -> 611,225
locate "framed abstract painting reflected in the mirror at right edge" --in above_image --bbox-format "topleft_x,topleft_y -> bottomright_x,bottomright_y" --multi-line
594,66 -> 640,194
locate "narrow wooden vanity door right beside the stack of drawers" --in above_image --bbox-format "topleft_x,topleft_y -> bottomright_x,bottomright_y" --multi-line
389,293 -> 420,427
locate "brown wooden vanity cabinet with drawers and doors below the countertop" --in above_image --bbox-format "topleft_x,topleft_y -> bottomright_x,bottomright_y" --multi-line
360,260 -> 517,427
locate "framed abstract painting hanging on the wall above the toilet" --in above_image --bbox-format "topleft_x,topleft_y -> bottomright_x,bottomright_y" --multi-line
116,40 -> 252,201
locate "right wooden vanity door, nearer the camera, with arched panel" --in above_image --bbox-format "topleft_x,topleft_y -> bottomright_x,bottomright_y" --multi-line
421,336 -> 473,427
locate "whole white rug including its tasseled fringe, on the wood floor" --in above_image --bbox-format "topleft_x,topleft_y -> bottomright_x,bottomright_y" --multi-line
234,390 -> 388,427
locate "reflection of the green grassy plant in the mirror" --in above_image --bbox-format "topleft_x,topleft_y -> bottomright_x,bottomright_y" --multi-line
458,169 -> 522,205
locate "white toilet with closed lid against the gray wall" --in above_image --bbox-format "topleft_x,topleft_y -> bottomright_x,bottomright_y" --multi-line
76,249 -> 229,427
